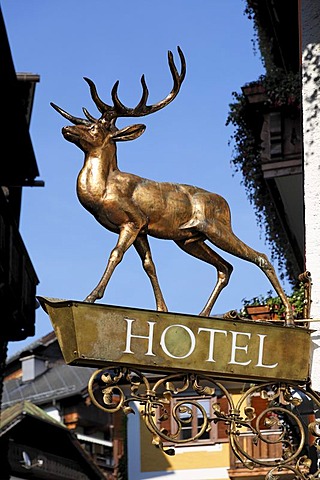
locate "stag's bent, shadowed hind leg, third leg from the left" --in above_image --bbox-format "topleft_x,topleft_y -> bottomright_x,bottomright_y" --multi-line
175,239 -> 233,317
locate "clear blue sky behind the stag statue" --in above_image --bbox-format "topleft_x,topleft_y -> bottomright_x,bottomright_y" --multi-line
1,0 -> 289,355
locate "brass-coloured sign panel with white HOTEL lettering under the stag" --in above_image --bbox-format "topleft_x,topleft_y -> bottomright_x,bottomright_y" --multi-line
38,297 -> 311,381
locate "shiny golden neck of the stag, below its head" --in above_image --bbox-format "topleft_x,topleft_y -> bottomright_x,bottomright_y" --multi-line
77,144 -> 119,204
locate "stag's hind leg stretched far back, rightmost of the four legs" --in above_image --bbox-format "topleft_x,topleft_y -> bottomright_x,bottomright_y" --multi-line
205,225 -> 294,326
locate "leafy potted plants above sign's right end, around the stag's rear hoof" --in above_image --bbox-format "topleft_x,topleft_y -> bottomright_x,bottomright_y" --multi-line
240,282 -> 305,319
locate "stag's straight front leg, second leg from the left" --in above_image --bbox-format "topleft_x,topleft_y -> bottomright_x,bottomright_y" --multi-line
133,236 -> 168,312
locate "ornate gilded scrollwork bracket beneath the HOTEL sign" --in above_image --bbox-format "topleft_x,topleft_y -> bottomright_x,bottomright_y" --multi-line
88,367 -> 320,474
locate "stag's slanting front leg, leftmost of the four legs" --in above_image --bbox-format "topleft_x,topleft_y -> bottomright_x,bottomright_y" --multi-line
84,224 -> 139,303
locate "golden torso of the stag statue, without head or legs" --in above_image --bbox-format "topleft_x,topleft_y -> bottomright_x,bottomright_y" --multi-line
77,158 -> 230,240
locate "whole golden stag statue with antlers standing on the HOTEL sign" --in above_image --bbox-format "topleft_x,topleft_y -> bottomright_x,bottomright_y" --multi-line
51,47 -> 293,325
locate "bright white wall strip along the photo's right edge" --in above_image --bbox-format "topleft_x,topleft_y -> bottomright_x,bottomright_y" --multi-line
301,0 -> 320,391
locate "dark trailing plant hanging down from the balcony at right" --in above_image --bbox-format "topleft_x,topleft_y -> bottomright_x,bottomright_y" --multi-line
226,67 -> 301,283
